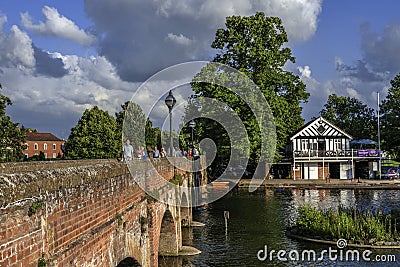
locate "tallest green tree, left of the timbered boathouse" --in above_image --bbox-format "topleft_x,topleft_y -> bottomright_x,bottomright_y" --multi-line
192,12 -> 309,162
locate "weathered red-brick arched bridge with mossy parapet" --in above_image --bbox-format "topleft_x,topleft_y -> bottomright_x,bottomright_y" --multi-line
0,158 -> 204,267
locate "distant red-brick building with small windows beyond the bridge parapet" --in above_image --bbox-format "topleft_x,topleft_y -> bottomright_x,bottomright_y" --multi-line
22,132 -> 65,159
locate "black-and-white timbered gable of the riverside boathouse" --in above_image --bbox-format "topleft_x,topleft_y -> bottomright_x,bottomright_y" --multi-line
290,117 -> 353,140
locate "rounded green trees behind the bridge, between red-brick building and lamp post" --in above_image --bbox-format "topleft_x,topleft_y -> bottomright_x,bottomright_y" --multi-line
66,102 -> 161,159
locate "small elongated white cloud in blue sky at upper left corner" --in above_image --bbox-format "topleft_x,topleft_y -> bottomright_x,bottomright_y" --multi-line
21,6 -> 94,45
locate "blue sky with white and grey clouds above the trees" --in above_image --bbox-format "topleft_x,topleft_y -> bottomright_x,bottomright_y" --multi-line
0,0 -> 400,139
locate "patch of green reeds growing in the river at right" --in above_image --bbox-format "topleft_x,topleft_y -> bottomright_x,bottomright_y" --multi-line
296,205 -> 400,244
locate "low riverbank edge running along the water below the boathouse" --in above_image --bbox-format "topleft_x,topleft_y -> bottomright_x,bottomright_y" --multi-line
237,179 -> 400,190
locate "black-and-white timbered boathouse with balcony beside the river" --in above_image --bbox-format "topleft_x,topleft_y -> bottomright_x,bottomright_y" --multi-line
289,117 -> 380,180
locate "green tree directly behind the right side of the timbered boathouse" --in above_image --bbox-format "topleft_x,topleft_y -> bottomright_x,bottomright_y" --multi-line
320,94 -> 378,141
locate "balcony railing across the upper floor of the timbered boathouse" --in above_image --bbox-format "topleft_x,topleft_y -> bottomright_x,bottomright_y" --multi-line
293,149 -> 380,158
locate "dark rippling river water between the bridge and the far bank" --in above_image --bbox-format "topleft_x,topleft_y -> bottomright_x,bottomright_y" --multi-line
159,188 -> 400,267
